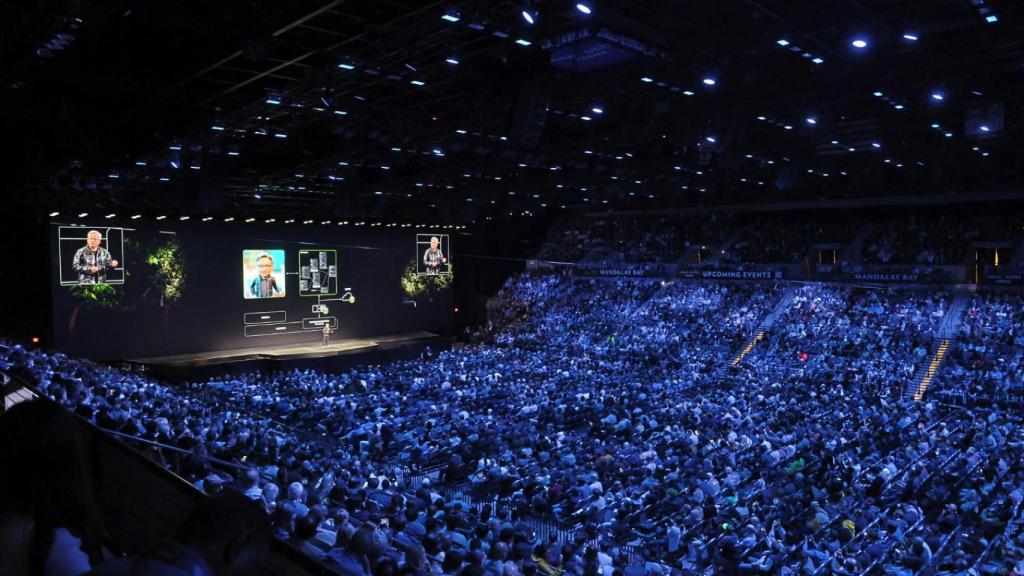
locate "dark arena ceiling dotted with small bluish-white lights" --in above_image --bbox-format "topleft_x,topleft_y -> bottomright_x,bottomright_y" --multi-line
8,0 -> 1024,222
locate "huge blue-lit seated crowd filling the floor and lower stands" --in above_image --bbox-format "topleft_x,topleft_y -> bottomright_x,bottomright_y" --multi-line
0,274 -> 1024,576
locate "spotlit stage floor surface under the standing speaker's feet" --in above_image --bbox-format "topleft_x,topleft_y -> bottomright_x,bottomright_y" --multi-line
125,332 -> 437,367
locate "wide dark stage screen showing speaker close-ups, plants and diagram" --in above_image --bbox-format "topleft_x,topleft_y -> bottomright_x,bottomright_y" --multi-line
51,220 -> 454,360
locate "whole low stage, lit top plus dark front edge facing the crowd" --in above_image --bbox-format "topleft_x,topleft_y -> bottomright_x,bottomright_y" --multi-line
124,332 -> 449,379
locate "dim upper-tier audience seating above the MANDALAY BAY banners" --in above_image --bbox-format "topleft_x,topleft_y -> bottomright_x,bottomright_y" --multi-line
538,206 -> 1024,269
